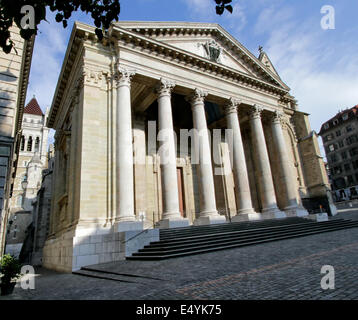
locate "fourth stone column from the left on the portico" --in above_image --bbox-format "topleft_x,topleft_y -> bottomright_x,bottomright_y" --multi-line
225,99 -> 255,221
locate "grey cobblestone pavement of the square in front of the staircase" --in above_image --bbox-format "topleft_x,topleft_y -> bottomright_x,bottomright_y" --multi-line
0,209 -> 358,300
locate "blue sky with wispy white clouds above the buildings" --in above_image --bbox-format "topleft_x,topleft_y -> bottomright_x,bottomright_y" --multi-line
27,0 -> 358,157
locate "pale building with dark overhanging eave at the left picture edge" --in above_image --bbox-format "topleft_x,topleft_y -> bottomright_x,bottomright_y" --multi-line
0,27 -> 34,256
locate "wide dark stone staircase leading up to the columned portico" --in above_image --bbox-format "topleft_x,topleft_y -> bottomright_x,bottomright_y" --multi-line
126,217 -> 358,260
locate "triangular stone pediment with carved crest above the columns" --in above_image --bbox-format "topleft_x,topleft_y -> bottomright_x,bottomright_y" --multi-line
116,21 -> 289,90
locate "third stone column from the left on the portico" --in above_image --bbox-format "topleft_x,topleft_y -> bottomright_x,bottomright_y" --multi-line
189,89 -> 226,225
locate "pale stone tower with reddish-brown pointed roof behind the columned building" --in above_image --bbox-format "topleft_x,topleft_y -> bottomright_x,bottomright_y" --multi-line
5,97 -> 49,257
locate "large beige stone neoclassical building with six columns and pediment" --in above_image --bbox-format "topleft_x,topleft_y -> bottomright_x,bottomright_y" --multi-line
43,22 -> 334,271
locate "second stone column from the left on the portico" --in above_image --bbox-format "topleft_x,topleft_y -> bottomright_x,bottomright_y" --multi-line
156,79 -> 189,228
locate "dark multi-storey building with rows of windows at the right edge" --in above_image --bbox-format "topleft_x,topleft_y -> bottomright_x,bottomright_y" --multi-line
319,105 -> 358,201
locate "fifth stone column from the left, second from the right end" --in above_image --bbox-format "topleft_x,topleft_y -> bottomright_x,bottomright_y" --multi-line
249,105 -> 286,219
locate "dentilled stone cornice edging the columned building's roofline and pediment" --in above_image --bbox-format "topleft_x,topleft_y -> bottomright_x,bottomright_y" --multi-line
47,22 -> 291,128
